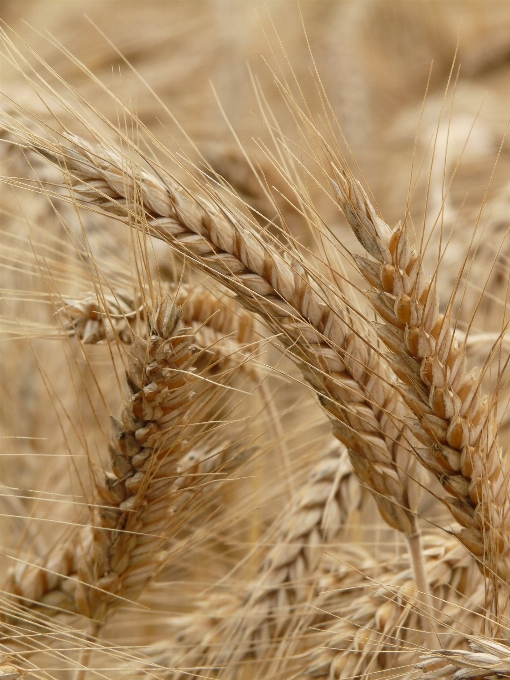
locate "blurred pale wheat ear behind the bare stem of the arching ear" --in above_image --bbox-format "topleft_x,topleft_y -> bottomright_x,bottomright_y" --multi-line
304,536 -> 484,680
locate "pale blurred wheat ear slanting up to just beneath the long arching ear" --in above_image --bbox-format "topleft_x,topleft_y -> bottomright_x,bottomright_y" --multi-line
213,442 -> 363,677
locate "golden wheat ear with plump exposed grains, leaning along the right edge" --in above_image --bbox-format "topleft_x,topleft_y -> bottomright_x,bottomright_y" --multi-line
332,165 -> 510,583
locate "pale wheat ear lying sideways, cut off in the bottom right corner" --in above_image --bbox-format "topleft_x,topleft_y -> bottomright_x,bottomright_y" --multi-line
416,637 -> 510,680
